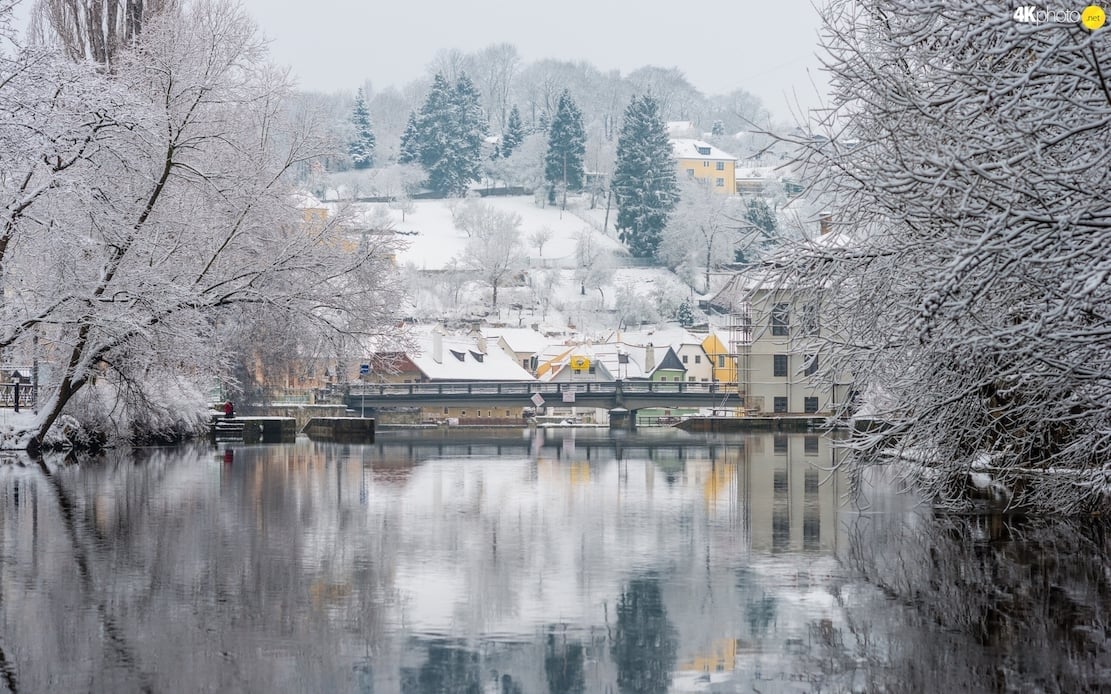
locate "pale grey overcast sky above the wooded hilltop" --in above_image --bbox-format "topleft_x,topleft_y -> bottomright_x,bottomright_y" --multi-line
242,0 -> 825,120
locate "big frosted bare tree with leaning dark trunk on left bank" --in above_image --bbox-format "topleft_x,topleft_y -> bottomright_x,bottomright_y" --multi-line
0,0 -> 398,445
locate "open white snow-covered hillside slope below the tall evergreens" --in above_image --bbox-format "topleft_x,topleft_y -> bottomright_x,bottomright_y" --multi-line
335,195 -> 699,334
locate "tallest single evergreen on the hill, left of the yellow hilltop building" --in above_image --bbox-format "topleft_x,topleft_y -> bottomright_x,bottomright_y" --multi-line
612,95 -> 679,258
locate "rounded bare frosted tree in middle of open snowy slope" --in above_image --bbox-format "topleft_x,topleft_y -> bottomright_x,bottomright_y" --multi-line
456,201 -> 526,308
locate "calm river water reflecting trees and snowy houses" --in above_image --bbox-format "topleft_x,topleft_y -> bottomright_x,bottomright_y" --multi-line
0,429 -> 1111,694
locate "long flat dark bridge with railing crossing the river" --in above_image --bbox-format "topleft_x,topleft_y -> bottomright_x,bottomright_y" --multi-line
343,381 -> 744,411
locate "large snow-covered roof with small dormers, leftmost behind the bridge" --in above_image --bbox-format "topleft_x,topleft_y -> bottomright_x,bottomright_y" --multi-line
409,331 -> 536,381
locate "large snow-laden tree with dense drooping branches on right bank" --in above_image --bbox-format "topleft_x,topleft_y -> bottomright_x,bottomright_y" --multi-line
775,0 -> 1111,513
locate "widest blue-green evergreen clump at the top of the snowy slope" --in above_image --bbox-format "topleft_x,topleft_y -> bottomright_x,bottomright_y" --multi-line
399,73 -> 487,195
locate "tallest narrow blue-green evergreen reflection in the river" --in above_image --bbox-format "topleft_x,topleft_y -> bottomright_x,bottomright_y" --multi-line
610,576 -> 679,693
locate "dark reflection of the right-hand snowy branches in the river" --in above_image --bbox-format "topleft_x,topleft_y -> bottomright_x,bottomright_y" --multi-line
829,516 -> 1111,692
